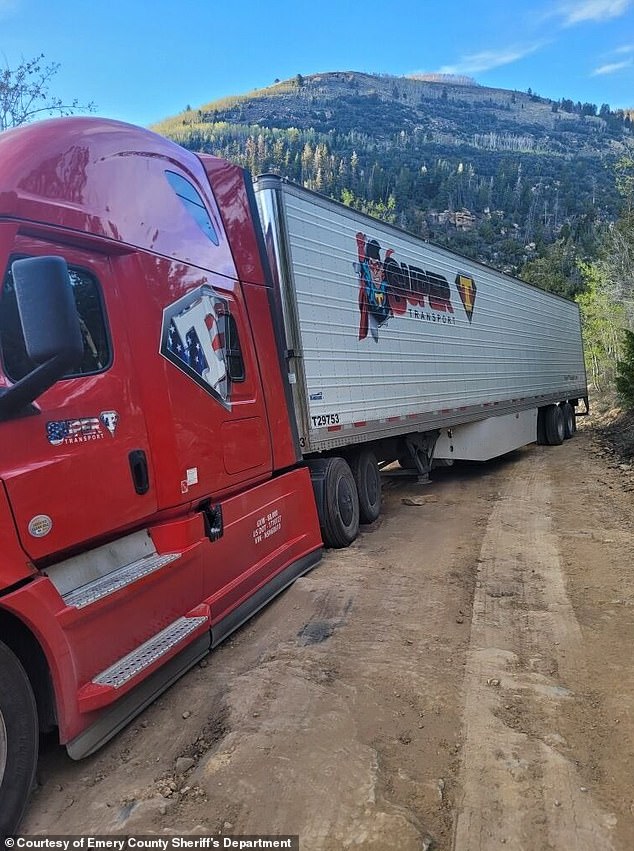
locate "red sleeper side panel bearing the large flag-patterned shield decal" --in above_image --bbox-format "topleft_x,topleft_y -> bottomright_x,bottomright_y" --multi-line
127,253 -> 272,509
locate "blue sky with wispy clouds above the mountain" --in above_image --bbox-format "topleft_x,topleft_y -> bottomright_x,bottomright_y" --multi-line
0,0 -> 634,125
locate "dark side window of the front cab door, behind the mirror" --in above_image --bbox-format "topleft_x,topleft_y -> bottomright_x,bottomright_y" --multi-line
0,257 -> 111,382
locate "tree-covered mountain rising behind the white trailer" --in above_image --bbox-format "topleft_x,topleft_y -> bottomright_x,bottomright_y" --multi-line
154,72 -> 634,294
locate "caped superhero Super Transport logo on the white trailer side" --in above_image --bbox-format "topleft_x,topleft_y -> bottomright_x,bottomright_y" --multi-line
353,233 -> 476,342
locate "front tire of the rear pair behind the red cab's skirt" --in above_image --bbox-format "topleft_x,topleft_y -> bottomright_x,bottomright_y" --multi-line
311,458 -> 359,549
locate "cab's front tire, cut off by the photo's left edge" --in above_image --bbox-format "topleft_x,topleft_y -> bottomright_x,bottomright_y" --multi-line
0,642 -> 39,839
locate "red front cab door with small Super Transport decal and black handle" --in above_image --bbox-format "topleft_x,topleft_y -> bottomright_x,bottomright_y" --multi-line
0,237 -> 156,560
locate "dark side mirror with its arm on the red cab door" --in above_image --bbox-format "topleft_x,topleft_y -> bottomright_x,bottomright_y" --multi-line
0,257 -> 84,419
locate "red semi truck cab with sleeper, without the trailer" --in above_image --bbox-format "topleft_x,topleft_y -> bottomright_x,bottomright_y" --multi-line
0,118 -> 322,833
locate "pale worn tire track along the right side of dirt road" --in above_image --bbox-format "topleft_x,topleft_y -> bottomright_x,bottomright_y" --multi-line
454,449 -> 613,851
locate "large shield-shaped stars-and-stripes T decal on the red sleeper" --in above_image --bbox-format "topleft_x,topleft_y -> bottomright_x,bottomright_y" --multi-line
161,284 -> 231,408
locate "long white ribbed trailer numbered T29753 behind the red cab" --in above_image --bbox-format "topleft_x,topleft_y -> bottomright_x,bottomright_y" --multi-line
255,175 -> 587,544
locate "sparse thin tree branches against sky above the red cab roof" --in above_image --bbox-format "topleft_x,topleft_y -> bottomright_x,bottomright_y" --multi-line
0,53 -> 95,131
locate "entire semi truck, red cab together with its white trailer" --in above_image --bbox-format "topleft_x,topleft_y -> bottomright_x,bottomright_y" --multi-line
0,118 -> 587,835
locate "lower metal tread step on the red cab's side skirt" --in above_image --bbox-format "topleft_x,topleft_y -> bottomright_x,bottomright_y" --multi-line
78,607 -> 209,712
